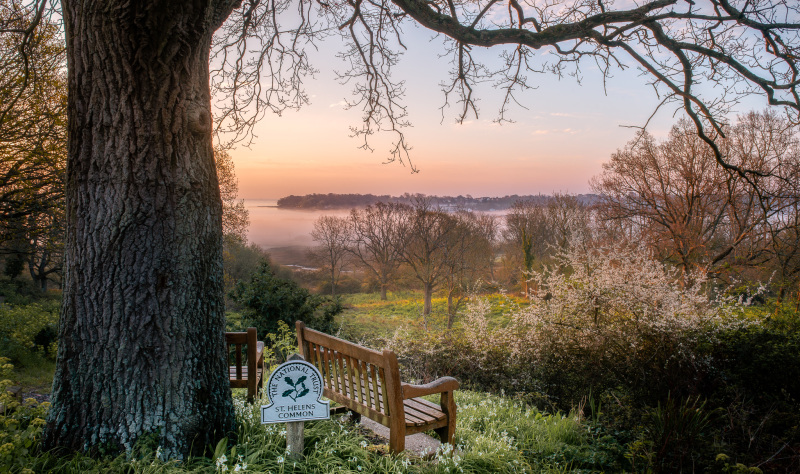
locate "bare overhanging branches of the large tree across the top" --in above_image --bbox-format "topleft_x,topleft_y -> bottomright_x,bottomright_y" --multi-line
212,0 -> 800,174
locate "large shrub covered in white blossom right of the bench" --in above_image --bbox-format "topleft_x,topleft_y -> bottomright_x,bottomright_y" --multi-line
389,244 -> 754,409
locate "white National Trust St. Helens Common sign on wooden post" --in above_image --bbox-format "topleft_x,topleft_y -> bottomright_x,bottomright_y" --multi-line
261,354 -> 331,459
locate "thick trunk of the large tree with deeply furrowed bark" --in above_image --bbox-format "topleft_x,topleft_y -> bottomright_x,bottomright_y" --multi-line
44,0 -> 234,458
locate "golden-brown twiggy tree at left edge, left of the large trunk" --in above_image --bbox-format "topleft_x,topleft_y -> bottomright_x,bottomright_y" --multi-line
0,0 -> 67,290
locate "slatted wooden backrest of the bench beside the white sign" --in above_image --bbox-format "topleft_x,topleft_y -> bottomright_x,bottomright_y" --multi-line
296,321 -> 403,421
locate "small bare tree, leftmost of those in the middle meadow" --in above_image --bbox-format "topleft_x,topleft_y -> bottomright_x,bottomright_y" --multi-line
311,216 -> 351,296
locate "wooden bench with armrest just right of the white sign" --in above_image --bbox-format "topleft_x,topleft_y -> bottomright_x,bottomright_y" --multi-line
296,321 -> 458,453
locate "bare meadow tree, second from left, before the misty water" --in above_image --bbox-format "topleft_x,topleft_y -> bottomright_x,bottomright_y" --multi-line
348,202 -> 409,301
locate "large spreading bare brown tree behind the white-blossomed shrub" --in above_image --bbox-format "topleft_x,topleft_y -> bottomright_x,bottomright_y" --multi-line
592,114 -> 800,284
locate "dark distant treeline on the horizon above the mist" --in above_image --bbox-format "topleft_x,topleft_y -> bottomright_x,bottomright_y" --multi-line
278,193 -> 599,211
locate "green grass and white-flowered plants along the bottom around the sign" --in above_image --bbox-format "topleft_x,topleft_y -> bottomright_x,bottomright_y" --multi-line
0,384 -> 615,474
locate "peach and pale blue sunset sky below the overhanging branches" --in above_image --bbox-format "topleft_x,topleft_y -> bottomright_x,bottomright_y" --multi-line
231,28 -> 759,199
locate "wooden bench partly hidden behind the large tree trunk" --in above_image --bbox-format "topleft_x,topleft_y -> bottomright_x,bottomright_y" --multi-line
225,328 -> 264,401
